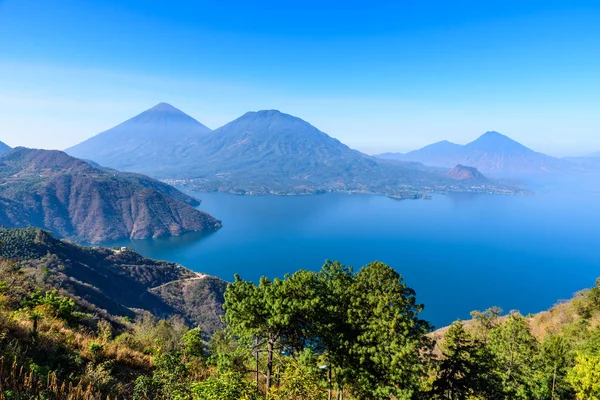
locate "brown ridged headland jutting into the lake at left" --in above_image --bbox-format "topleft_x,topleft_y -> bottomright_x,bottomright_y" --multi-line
0,147 -> 221,243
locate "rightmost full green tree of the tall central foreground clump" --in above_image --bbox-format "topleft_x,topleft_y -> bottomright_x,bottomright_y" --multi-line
348,262 -> 431,399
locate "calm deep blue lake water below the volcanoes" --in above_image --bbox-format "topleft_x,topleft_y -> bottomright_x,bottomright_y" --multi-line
108,176 -> 600,327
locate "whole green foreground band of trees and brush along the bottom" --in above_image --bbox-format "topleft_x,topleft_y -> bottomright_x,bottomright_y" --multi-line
0,230 -> 600,400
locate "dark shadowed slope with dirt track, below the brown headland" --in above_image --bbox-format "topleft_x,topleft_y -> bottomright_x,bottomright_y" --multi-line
0,228 -> 227,332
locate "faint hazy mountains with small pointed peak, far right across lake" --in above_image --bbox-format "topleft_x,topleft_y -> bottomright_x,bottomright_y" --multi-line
377,131 -> 576,177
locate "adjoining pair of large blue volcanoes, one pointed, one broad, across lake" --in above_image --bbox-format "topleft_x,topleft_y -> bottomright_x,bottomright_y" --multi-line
66,104 -> 512,197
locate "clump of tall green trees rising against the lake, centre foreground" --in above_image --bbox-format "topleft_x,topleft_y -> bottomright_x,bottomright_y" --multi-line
225,263 -> 430,398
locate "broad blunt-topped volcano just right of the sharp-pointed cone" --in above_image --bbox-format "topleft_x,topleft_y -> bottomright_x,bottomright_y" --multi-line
64,105 -> 506,196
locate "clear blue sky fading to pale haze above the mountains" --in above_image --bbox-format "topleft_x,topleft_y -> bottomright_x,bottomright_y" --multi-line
0,0 -> 600,155
